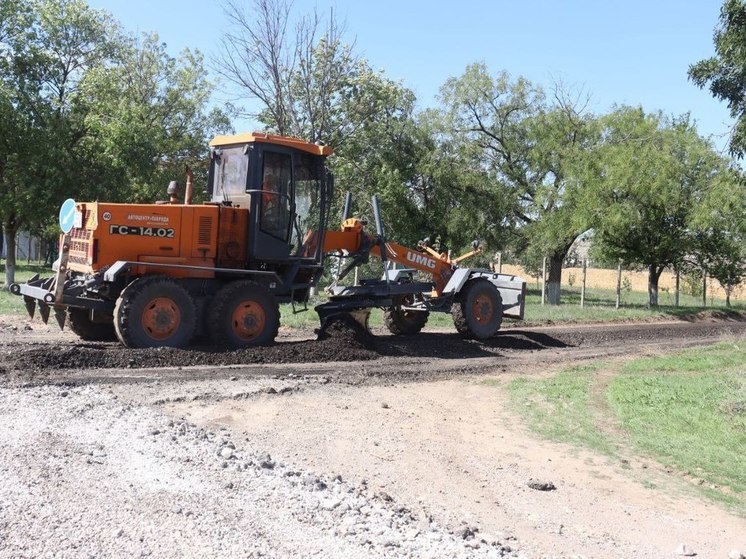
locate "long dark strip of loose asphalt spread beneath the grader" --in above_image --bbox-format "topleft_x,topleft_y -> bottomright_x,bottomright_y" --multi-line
0,314 -> 746,378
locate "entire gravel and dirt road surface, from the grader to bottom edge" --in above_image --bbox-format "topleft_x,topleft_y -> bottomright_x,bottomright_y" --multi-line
0,317 -> 746,559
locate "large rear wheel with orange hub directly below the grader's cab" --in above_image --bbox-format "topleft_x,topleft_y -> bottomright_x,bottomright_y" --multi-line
207,280 -> 280,348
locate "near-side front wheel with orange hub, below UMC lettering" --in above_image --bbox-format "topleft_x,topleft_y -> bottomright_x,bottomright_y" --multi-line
451,279 -> 503,340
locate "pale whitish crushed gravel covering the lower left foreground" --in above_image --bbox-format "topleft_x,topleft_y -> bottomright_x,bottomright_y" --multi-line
0,386 -> 517,559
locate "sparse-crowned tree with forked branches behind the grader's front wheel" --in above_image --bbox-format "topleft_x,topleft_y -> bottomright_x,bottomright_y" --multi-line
441,64 -> 596,304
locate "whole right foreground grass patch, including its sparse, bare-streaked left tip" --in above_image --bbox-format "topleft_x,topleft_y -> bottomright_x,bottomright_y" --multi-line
508,342 -> 746,515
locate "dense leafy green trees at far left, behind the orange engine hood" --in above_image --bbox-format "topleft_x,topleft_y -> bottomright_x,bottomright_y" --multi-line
0,0 -> 227,283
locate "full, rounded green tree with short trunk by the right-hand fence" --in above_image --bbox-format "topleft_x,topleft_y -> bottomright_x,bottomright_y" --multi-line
578,107 -> 723,307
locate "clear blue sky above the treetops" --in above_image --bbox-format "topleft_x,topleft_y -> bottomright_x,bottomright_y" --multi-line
89,0 -> 732,149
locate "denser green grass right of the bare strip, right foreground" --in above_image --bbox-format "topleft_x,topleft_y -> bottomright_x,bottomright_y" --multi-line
608,343 -> 746,493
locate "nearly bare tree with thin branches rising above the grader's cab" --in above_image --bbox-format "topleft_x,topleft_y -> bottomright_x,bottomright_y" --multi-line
214,0 -> 364,147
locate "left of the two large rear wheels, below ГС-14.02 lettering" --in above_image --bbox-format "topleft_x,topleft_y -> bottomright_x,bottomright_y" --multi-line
114,276 -> 197,348
